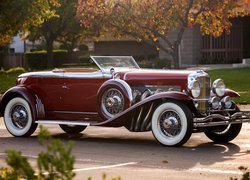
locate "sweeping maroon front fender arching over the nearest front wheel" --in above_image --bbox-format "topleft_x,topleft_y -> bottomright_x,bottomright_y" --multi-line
91,92 -> 197,132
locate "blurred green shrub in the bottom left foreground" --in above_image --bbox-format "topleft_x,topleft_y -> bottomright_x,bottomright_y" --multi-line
0,126 -> 75,180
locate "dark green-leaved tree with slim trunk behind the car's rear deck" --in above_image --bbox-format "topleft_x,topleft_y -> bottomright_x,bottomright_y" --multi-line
29,0 -> 82,68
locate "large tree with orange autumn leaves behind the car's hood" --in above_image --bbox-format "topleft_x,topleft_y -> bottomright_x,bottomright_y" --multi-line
78,0 -> 248,68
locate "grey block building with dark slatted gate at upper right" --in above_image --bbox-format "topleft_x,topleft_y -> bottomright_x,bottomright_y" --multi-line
159,16 -> 250,67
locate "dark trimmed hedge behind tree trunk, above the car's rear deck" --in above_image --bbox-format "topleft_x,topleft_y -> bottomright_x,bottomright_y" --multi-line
25,50 -> 68,70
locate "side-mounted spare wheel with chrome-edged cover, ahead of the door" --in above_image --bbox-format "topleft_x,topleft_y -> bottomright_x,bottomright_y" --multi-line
97,79 -> 133,120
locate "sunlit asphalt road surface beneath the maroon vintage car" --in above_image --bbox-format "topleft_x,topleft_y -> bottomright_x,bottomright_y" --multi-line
0,116 -> 250,180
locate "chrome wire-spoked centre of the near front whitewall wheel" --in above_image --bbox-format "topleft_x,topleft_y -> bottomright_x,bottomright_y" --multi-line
158,110 -> 181,137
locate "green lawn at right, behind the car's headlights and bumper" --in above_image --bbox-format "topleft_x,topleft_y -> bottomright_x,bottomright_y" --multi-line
207,68 -> 250,104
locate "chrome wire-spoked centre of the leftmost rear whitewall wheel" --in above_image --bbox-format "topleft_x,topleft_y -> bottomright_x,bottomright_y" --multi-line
10,105 -> 28,129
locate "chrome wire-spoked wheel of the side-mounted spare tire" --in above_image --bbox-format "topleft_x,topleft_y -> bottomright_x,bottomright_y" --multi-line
101,88 -> 124,117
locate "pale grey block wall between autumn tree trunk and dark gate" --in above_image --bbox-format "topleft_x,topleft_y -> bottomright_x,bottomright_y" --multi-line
159,27 -> 201,67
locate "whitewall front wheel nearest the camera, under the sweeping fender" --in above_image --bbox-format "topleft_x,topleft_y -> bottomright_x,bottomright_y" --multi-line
152,102 -> 193,146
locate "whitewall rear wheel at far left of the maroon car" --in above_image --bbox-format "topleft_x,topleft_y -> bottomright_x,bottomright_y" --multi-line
4,97 -> 37,137
